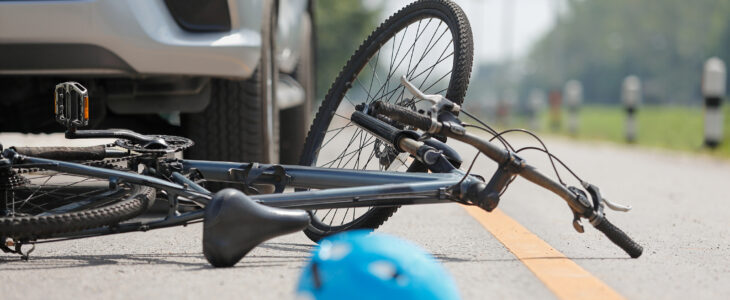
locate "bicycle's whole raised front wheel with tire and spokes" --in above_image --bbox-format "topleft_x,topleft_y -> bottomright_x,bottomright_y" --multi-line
300,0 -> 473,241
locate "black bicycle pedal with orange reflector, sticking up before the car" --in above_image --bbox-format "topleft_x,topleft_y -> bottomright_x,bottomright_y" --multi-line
53,81 -> 89,129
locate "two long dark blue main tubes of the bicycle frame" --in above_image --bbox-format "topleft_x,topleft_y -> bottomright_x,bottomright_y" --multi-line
183,161 -> 466,210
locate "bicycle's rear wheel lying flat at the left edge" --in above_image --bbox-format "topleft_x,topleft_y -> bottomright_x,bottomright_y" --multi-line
0,151 -> 155,240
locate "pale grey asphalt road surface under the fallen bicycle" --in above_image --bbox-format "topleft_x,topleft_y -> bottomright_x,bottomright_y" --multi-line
0,134 -> 730,299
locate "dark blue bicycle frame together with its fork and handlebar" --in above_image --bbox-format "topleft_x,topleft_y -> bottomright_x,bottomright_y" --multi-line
3,85 -> 643,258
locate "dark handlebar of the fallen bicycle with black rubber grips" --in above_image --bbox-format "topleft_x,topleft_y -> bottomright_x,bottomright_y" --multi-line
366,102 -> 643,258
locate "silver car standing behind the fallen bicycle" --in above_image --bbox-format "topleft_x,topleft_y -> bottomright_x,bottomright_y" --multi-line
0,0 -> 314,163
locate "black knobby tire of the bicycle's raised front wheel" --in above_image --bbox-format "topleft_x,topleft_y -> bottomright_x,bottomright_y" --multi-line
300,0 -> 473,241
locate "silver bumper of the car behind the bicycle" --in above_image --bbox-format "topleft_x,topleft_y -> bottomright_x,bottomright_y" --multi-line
0,0 -> 263,78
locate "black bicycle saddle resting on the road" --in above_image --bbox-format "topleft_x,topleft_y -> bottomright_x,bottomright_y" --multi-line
203,189 -> 309,267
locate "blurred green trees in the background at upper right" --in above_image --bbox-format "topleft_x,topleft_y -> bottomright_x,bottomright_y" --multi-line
522,0 -> 730,103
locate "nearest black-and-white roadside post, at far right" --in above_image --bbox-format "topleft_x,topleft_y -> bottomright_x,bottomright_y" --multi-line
702,57 -> 725,148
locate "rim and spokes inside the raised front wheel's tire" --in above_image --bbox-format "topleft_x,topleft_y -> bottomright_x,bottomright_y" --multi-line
304,14 -> 455,232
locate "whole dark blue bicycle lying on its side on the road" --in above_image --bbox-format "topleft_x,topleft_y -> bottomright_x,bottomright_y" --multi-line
0,0 -> 642,266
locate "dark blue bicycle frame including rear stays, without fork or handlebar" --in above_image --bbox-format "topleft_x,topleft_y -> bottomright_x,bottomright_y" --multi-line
14,155 -> 478,239
